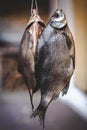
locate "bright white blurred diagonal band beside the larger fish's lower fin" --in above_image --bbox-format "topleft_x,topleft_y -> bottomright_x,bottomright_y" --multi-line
60,77 -> 87,120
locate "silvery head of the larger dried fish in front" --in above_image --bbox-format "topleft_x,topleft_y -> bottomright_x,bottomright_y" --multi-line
50,9 -> 67,29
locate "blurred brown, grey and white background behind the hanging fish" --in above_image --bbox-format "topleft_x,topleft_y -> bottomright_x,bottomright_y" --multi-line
0,0 -> 87,130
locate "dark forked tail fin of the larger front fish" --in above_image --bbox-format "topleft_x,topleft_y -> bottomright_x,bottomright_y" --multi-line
30,104 -> 47,129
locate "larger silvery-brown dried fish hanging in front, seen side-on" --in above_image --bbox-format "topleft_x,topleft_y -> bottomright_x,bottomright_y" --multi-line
31,10 -> 75,127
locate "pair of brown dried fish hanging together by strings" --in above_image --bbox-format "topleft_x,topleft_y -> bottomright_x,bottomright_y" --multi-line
18,3 -> 75,127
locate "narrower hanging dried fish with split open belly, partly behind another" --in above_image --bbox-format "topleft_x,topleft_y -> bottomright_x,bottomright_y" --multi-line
18,1 -> 45,110
